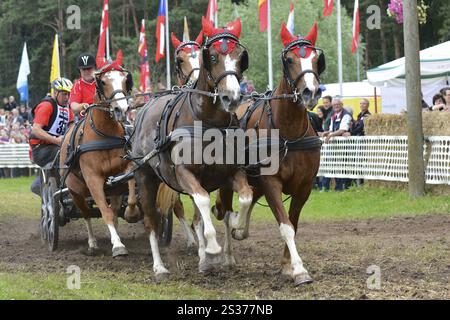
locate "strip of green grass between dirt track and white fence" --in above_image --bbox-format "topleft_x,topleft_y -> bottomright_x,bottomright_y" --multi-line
0,178 -> 450,222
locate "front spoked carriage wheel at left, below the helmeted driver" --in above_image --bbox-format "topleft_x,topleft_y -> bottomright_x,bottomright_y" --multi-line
45,177 -> 60,251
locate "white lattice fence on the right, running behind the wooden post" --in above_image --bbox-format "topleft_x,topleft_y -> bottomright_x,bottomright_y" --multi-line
318,136 -> 450,184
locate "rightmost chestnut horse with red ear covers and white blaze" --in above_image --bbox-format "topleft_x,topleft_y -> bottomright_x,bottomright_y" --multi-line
214,23 -> 325,285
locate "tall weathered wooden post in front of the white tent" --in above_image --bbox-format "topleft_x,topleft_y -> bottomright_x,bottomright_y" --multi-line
403,0 -> 425,198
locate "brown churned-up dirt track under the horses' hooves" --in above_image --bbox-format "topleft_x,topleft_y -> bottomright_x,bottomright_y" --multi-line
0,215 -> 450,299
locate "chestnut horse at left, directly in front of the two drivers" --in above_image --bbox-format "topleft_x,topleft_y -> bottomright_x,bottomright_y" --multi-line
60,53 -> 133,257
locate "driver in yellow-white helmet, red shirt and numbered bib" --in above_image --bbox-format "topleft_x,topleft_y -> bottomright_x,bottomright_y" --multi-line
30,78 -> 74,167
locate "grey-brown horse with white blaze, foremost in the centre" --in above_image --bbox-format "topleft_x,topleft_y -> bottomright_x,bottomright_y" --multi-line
132,18 -> 252,275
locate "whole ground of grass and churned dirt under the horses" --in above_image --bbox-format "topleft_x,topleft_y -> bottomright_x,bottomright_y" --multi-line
0,178 -> 450,300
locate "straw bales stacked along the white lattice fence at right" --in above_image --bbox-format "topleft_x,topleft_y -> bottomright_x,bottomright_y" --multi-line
364,112 -> 450,195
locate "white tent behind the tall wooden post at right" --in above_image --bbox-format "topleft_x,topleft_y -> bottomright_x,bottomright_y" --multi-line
367,41 -> 450,113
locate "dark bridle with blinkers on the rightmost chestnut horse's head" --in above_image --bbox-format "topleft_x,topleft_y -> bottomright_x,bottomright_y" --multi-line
280,39 -> 325,95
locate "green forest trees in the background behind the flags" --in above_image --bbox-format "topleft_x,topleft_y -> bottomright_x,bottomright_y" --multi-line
0,0 -> 450,104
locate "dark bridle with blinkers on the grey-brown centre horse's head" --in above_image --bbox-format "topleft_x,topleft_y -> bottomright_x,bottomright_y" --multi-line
202,31 -> 248,99
